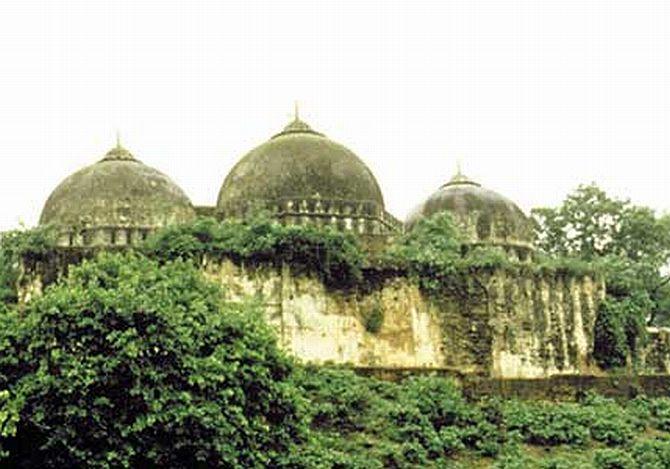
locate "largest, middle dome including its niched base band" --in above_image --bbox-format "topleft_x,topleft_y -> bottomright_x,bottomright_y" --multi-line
217,116 -> 397,234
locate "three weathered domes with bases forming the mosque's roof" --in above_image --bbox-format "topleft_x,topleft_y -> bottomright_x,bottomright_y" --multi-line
39,112 -> 533,259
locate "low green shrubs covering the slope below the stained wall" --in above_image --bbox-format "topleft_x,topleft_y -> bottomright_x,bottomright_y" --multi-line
294,368 -> 670,469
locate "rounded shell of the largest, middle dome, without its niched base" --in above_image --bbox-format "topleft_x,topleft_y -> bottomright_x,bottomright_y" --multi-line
217,116 -> 384,216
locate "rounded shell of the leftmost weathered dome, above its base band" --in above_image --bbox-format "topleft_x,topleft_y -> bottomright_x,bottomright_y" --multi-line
40,144 -> 195,238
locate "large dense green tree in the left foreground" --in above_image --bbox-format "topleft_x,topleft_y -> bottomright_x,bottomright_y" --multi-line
0,253 -> 303,467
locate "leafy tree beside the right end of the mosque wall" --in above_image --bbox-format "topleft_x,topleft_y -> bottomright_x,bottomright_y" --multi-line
532,184 -> 670,367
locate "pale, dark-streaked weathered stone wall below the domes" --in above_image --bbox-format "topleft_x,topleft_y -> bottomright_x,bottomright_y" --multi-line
203,259 -> 604,378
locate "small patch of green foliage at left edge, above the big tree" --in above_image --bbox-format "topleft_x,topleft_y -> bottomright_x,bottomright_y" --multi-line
0,227 -> 55,304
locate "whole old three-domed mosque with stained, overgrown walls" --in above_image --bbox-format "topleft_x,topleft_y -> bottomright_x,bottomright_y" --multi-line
19,109 -> 624,378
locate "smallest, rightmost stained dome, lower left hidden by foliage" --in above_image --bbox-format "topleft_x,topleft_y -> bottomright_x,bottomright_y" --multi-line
405,170 -> 533,251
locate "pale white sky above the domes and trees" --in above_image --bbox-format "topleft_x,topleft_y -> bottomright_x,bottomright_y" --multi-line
0,0 -> 670,229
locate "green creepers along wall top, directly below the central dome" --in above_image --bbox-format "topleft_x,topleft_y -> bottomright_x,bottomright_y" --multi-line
142,214 -> 365,287
